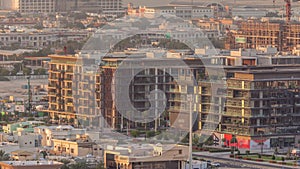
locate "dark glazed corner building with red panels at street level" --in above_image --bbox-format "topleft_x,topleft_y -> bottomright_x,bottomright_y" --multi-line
221,67 -> 300,149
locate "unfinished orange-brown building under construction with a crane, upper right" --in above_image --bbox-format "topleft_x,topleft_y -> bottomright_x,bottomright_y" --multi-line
225,0 -> 300,52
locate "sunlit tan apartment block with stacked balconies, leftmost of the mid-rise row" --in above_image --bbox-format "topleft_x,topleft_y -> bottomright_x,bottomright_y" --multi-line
48,55 -> 101,127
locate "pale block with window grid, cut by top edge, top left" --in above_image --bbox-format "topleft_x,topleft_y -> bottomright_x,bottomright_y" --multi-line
18,0 -> 56,13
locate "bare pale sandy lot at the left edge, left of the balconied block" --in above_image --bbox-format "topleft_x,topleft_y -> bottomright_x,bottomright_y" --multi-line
0,79 -> 48,98
